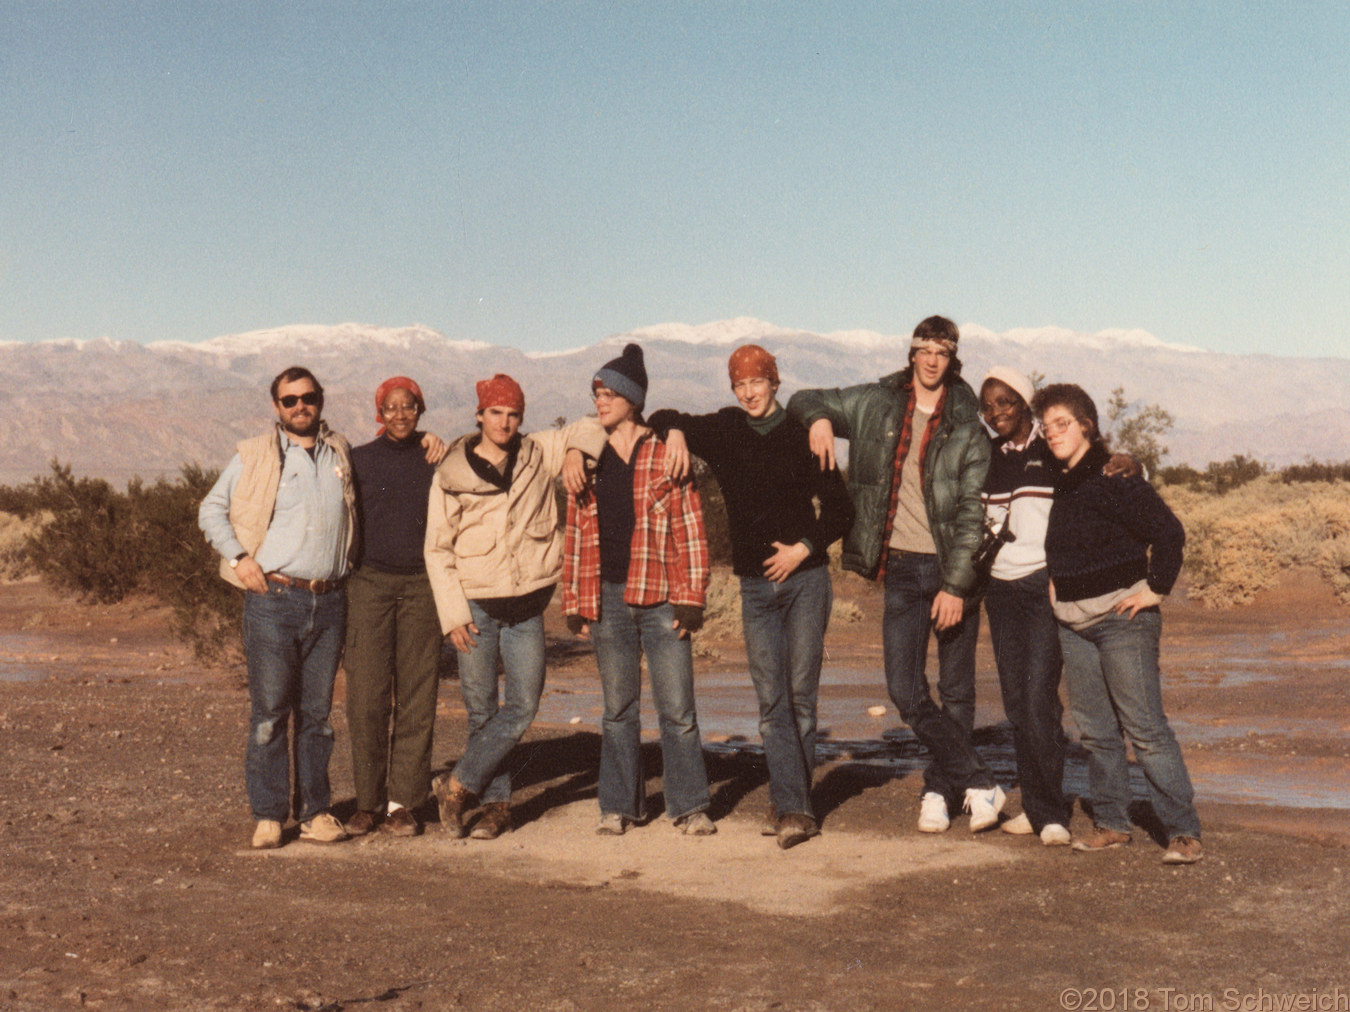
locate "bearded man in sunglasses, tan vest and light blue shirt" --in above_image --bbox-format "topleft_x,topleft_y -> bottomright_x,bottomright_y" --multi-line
197,366 -> 356,849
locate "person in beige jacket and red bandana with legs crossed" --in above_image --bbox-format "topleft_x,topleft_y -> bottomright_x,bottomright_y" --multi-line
425,374 -> 605,839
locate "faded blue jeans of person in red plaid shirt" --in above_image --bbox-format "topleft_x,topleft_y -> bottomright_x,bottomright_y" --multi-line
590,583 -> 711,822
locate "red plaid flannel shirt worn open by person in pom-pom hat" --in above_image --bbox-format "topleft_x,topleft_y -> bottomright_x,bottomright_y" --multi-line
563,436 -> 709,622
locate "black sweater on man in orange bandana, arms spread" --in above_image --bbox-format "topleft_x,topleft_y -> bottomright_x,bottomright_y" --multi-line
648,407 -> 853,576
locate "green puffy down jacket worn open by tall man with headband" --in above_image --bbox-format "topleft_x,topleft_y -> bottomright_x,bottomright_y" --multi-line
787,372 -> 990,598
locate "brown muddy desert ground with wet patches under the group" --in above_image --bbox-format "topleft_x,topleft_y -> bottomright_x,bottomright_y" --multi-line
0,578 -> 1350,1012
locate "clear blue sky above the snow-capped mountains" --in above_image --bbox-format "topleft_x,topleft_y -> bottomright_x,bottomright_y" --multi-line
0,0 -> 1350,355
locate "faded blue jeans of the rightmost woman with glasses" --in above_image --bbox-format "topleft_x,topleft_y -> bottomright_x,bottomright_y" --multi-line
1060,609 -> 1200,839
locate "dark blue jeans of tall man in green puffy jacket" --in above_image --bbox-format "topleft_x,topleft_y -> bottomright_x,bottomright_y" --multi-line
882,552 -> 994,804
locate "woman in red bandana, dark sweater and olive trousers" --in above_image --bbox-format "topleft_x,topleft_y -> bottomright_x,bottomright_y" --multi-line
343,376 -> 446,837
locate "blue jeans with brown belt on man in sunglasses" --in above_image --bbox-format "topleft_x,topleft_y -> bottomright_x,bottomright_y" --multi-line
243,583 -> 347,822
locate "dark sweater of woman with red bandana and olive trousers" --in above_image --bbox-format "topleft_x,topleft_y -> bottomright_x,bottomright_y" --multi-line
351,432 -> 436,576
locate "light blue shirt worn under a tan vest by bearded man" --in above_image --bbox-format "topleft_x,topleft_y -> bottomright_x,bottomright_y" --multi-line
197,437 -> 347,580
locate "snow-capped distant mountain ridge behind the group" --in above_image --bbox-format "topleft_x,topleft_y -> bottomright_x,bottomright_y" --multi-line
0,317 -> 1350,483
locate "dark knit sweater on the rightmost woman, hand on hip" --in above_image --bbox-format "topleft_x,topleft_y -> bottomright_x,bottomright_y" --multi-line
1045,444 -> 1185,600
